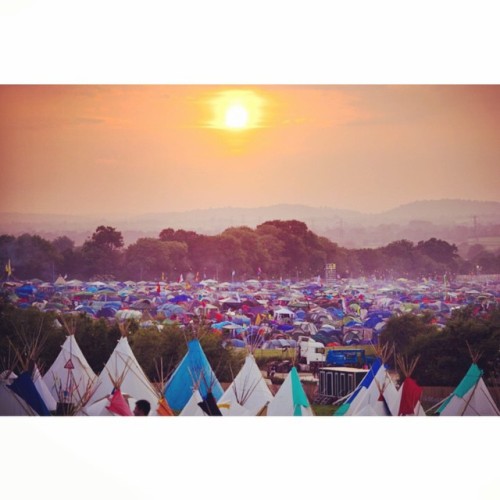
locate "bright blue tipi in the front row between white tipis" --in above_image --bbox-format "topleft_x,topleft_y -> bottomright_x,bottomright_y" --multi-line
165,339 -> 224,411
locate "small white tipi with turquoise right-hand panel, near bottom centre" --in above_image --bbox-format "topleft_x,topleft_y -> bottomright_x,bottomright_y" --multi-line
267,366 -> 314,417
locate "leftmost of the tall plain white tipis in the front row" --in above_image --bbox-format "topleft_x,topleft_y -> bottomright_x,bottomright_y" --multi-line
42,335 -> 97,403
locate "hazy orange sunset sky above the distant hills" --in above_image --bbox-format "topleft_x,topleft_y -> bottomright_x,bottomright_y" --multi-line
0,85 -> 500,214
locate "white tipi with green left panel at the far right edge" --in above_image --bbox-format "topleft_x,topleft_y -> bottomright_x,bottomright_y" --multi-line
436,363 -> 500,416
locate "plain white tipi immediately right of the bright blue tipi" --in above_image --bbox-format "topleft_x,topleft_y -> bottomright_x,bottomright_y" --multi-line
218,354 -> 273,415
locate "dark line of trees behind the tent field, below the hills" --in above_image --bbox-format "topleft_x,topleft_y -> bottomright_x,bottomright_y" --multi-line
0,220 -> 500,281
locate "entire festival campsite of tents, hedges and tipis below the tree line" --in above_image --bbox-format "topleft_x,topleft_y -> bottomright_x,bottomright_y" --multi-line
0,276 -> 500,417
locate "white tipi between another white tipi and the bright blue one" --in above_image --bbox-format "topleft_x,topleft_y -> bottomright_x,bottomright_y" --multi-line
87,336 -> 159,415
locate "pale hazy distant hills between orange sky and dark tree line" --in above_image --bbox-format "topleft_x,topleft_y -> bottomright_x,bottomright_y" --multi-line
0,200 -> 500,248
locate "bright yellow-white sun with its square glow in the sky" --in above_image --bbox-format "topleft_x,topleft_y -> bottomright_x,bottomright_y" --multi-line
208,90 -> 263,131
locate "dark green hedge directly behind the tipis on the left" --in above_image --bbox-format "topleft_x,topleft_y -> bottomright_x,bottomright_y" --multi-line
0,302 -> 245,383
